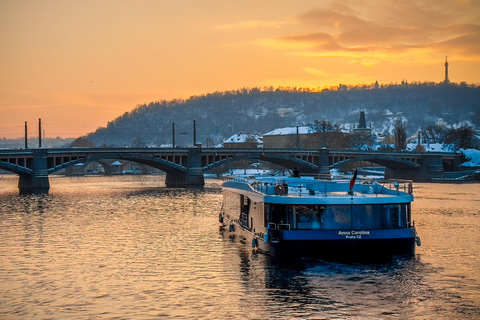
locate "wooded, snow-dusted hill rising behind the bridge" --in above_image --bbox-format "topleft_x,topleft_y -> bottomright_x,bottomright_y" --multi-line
87,83 -> 480,146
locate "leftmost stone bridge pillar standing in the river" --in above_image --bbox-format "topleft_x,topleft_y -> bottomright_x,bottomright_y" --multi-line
18,149 -> 50,194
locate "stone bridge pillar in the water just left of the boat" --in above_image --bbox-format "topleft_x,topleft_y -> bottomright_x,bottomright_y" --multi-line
165,148 -> 205,188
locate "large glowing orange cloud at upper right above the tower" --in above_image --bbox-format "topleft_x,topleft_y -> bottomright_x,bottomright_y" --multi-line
253,1 -> 480,66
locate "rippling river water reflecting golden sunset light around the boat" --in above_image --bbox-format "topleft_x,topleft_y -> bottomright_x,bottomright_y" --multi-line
0,176 -> 480,319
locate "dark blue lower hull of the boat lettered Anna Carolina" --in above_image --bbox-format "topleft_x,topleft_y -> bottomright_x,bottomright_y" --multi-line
223,220 -> 416,261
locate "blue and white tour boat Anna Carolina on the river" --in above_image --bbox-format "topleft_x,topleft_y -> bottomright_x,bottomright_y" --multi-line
219,175 -> 420,259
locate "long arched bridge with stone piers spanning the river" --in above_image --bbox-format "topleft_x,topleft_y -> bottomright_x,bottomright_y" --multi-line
0,148 -> 460,194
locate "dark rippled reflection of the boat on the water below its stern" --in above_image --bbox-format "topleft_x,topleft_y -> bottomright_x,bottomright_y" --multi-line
231,244 -> 433,319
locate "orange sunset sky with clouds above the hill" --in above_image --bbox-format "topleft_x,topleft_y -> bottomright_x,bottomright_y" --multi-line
0,0 -> 480,138
